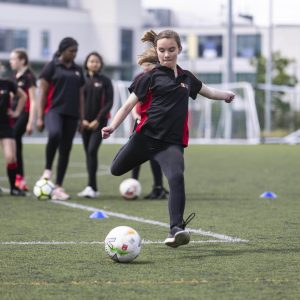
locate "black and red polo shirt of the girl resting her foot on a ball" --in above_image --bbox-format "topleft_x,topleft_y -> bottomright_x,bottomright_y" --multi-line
40,58 -> 84,118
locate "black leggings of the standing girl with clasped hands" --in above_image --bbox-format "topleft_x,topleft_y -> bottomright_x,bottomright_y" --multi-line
82,121 -> 107,191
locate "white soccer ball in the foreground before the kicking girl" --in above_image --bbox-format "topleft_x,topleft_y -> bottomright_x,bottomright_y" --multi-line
104,226 -> 142,263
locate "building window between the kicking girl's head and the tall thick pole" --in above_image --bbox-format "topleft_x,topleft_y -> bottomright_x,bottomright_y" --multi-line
198,35 -> 223,58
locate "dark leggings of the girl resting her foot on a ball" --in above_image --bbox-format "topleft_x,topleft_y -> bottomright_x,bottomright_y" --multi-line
45,111 -> 78,186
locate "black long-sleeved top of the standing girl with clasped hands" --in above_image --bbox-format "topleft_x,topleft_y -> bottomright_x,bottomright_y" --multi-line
84,73 -> 114,122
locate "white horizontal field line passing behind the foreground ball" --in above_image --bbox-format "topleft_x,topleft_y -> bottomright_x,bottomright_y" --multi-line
0,240 -> 238,246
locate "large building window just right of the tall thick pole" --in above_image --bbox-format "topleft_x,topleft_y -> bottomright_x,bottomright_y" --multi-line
236,34 -> 261,58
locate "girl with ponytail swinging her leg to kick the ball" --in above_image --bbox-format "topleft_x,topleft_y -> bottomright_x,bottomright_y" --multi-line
102,30 -> 235,248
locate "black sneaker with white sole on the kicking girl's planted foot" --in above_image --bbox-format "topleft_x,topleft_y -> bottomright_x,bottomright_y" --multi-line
164,213 -> 195,248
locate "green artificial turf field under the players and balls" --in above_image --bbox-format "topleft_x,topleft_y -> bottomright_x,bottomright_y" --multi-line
0,144 -> 300,300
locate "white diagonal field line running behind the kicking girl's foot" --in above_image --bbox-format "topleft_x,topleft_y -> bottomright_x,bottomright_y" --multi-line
50,200 -> 248,243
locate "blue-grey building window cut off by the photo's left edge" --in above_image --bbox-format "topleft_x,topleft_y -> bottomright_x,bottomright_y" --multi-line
0,29 -> 28,52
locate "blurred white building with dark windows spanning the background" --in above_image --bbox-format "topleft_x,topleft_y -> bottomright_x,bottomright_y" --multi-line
0,0 -> 300,83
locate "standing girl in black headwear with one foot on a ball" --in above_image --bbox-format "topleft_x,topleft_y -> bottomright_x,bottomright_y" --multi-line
37,37 -> 84,200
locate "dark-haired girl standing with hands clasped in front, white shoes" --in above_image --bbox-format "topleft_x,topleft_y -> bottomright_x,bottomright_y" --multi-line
78,52 -> 114,198
